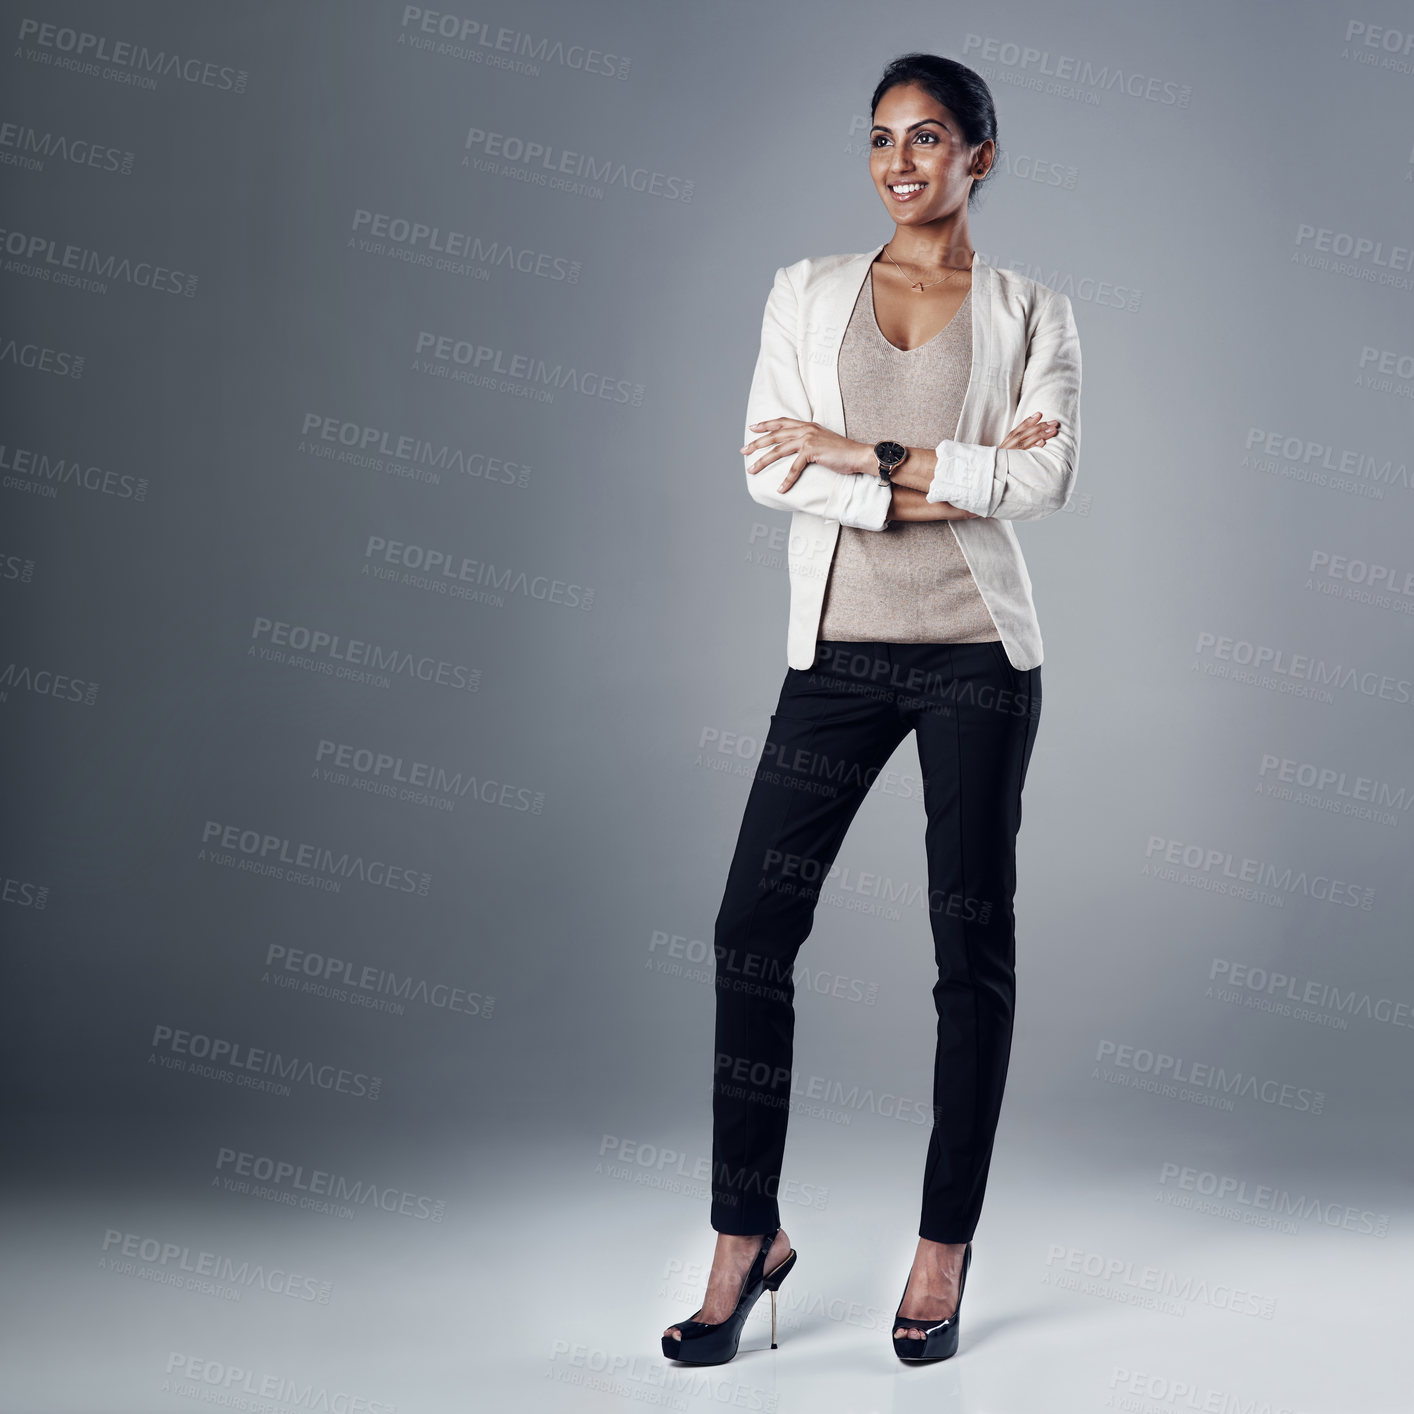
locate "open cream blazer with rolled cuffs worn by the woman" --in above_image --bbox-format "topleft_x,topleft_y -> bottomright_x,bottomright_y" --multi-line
742,243 -> 1080,669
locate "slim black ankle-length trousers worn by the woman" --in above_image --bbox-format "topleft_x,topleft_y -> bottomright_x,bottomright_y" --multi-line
711,641 -> 1041,1243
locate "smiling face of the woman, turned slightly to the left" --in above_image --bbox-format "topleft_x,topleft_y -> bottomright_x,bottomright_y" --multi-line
870,83 -> 994,226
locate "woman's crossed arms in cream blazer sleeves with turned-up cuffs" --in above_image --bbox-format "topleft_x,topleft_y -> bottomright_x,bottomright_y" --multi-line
741,267 -> 1080,530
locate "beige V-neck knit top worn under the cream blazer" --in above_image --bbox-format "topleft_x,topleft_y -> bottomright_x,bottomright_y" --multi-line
816,267 -> 1001,643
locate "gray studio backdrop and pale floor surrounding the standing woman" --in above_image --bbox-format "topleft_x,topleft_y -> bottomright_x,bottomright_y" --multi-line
0,0 -> 1414,1414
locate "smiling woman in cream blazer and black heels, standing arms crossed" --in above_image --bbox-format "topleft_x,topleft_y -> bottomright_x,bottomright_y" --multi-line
663,54 -> 1080,1365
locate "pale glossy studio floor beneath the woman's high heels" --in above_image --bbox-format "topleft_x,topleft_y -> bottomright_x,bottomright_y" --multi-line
0,1116 -> 1414,1414
